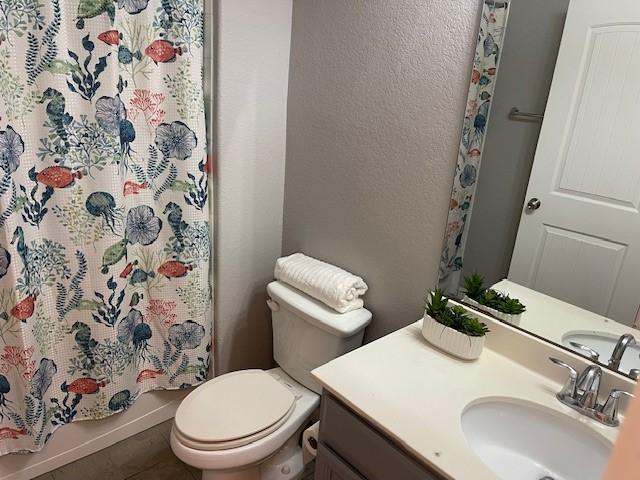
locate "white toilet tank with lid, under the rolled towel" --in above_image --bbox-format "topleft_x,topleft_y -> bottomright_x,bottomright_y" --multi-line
267,282 -> 371,393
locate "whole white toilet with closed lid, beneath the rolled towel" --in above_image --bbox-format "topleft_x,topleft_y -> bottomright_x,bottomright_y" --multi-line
171,281 -> 371,480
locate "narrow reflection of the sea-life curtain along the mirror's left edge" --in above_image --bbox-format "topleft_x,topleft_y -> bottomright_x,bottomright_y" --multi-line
439,0 -> 508,294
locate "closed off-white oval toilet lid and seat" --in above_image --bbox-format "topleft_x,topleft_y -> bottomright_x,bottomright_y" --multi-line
175,370 -> 295,449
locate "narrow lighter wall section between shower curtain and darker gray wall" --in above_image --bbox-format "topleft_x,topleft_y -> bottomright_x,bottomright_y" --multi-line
214,0 -> 292,374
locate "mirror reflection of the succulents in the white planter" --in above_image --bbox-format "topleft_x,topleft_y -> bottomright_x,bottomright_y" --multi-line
463,273 -> 527,325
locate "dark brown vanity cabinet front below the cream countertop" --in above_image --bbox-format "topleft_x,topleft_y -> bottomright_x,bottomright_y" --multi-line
315,391 -> 443,480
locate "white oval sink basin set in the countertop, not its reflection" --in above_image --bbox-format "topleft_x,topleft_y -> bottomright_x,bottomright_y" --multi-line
462,398 -> 611,480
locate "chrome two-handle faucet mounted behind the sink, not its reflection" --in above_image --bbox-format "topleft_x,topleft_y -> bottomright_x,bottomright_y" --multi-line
549,357 -> 633,427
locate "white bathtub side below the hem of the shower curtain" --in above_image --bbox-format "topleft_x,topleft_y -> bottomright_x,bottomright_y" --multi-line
0,390 -> 189,480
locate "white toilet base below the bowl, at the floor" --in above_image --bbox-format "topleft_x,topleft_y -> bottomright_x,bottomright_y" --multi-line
202,430 -> 304,480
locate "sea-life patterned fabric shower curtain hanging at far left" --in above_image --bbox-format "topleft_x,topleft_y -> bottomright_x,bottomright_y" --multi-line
0,0 -> 211,454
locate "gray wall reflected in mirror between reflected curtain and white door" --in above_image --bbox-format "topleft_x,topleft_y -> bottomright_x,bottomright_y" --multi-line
464,0 -> 569,283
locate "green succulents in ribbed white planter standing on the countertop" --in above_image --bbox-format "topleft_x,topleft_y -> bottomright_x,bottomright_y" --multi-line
422,288 -> 489,360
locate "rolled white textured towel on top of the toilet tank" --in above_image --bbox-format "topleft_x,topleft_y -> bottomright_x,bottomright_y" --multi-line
275,253 -> 369,313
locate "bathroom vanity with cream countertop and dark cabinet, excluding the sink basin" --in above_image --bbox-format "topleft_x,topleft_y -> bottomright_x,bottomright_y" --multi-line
313,317 -> 633,480
